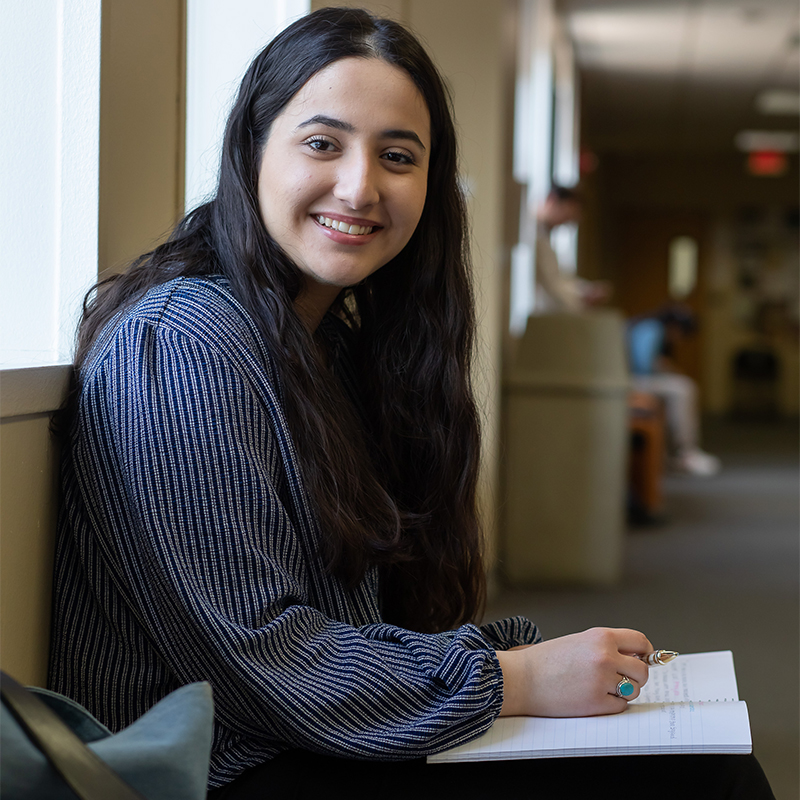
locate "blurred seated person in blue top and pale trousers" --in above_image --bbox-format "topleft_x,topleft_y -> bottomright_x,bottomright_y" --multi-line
628,304 -> 720,476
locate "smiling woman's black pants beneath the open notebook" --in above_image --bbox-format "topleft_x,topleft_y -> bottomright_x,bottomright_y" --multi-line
209,750 -> 775,800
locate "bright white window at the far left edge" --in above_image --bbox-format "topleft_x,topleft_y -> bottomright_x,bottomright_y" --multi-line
0,0 -> 101,368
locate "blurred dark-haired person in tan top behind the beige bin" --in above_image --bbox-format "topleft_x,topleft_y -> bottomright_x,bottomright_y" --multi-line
536,184 -> 611,313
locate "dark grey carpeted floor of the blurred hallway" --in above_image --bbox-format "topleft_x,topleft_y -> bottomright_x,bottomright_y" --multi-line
487,420 -> 800,800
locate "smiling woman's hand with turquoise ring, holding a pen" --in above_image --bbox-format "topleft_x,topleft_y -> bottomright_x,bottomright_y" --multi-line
497,628 -> 653,717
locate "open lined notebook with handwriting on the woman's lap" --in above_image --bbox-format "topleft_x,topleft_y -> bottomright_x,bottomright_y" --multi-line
428,650 -> 752,763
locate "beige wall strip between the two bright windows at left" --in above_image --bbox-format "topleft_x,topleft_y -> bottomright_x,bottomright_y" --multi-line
99,0 -> 185,272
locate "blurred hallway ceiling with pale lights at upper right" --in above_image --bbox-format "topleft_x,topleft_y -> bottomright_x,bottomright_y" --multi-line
557,0 -> 800,153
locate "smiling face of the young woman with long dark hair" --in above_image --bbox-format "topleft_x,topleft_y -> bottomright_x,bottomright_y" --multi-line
258,58 -> 431,323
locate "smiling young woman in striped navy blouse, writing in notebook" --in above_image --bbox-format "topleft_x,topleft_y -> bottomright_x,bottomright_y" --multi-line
51,9 -> 769,797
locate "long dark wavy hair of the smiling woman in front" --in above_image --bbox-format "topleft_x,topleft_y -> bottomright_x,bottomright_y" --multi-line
70,8 -> 485,631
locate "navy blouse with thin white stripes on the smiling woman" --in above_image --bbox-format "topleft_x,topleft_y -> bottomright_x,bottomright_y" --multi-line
50,279 -> 538,787
